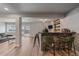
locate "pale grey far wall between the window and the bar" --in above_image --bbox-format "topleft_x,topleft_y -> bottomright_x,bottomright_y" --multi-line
30,22 -> 44,35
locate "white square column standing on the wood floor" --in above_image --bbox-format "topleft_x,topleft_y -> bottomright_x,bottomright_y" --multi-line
16,17 -> 22,47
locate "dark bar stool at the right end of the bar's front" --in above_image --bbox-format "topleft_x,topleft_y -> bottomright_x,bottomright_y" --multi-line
62,36 -> 76,55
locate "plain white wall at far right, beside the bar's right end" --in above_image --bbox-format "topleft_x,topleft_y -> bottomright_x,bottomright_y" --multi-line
64,7 -> 79,33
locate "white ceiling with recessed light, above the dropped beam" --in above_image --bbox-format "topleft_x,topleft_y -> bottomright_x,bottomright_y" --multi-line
0,3 -> 79,14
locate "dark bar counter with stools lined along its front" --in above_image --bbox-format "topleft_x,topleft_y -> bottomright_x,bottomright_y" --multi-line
41,32 -> 76,56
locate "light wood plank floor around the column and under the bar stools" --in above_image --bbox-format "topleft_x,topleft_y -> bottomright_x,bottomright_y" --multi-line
0,37 -> 78,56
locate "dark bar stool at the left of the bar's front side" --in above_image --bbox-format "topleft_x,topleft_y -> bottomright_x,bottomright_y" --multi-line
42,36 -> 55,56
